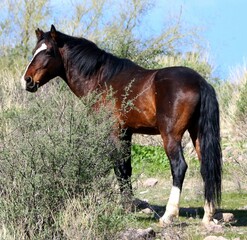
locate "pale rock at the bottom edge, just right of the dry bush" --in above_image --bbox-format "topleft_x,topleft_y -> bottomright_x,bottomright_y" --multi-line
118,228 -> 156,240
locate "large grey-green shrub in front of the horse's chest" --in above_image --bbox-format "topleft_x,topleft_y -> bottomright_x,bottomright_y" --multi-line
0,83 -> 129,239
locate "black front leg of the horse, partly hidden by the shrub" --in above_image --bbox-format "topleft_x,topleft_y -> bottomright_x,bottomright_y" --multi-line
114,130 -> 133,208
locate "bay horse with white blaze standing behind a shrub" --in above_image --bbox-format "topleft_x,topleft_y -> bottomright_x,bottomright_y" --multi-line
21,25 -> 222,225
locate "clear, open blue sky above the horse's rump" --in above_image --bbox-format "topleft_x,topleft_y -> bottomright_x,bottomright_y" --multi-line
153,0 -> 247,78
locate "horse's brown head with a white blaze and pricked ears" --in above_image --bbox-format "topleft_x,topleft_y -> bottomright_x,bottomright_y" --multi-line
21,25 -> 64,92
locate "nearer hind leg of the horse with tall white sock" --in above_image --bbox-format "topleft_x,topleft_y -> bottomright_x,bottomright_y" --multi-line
160,133 -> 187,224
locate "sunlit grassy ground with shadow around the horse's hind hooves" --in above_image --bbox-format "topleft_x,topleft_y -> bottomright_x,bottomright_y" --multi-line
128,143 -> 247,240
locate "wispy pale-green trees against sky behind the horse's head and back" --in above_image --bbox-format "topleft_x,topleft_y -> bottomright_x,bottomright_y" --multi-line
0,0 -> 201,68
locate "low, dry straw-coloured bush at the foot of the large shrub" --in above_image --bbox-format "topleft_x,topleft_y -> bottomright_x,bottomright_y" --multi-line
59,191 -> 136,240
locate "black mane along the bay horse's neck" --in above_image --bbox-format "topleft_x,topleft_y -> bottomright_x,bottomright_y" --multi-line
55,33 -> 139,81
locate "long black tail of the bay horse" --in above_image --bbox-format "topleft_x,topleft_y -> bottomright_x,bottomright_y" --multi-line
199,82 -> 222,205
